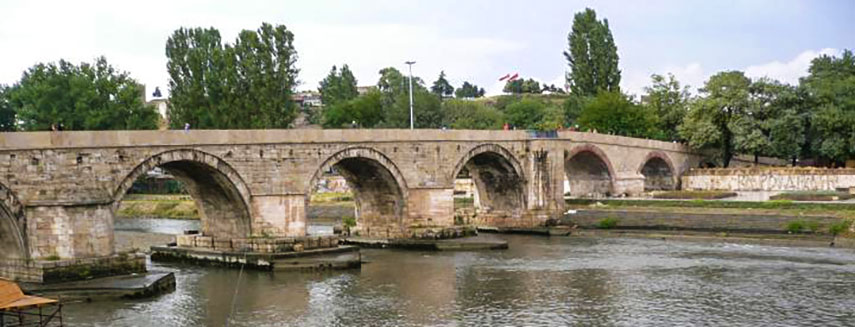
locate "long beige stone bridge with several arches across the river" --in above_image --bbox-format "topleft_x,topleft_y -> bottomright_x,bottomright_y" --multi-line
0,130 -> 699,266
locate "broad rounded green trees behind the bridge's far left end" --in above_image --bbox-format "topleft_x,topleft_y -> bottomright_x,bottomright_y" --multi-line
7,57 -> 158,131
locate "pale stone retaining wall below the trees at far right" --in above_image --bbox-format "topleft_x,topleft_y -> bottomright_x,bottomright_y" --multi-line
682,167 -> 855,191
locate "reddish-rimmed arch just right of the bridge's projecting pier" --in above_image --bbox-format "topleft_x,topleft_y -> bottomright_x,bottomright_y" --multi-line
564,144 -> 615,197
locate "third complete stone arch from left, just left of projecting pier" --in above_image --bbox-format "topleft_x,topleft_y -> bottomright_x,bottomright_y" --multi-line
450,144 -> 526,217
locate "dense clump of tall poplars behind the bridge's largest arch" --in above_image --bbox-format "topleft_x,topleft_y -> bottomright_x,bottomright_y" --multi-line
166,23 -> 299,128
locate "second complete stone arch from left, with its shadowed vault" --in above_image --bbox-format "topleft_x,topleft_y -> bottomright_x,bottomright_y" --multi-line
305,147 -> 408,237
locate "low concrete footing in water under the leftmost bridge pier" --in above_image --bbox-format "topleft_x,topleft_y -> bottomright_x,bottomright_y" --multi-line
21,272 -> 175,301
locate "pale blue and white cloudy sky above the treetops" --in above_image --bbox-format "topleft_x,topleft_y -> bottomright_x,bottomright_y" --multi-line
0,0 -> 855,97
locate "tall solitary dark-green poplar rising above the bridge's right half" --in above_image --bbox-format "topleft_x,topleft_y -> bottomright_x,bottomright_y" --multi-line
564,8 -> 620,96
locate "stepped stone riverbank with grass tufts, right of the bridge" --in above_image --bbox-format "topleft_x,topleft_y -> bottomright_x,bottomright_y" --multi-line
558,199 -> 855,248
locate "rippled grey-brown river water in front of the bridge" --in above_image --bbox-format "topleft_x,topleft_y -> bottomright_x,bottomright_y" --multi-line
64,219 -> 855,327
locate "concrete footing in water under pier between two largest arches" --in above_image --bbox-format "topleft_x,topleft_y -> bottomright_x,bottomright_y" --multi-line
151,245 -> 362,270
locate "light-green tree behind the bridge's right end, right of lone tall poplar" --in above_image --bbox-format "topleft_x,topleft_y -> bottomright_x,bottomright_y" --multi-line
643,74 -> 689,141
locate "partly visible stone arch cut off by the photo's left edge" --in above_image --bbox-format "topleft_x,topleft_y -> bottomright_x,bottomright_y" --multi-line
0,184 -> 30,260
